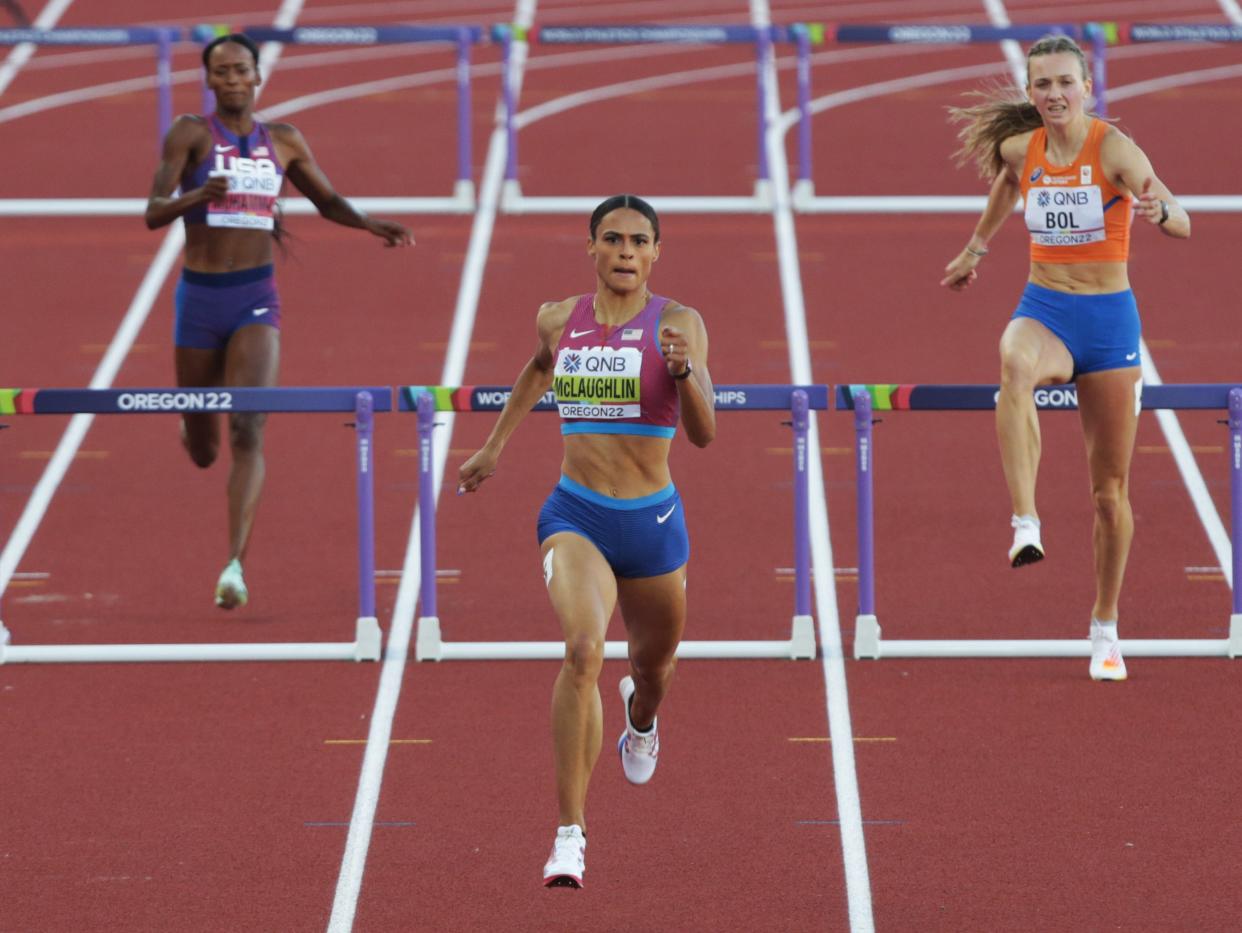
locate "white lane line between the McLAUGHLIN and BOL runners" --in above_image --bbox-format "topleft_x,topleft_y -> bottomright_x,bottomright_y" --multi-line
750,0 -> 876,933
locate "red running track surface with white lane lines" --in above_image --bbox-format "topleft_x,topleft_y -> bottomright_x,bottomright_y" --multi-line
0,0 -> 1242,931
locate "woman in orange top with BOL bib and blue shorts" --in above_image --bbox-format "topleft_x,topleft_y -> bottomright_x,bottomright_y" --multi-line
941,36 -> 1190,681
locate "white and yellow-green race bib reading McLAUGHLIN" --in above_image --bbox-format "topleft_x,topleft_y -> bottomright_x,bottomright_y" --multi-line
553,347 -> 642,420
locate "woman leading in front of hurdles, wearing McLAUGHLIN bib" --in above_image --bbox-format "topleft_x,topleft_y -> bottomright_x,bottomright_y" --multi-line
458,195 -> 715,887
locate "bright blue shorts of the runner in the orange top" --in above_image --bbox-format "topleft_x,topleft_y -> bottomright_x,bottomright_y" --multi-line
1013,282 -> 1143,379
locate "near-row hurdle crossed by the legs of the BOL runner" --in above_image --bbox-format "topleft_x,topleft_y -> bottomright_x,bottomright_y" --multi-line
836,384 -> 1242,658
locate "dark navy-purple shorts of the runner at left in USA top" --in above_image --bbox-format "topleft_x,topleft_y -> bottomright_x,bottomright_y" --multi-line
173,265 -> 281,350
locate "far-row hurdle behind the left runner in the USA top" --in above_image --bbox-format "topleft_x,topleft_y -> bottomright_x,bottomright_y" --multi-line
193,25 -> 484,214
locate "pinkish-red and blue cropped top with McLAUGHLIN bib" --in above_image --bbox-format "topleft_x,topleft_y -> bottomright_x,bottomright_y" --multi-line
553,294 -> 681,437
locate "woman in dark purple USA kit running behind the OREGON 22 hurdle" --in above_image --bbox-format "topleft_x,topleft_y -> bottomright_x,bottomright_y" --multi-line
147,35 -> 414,609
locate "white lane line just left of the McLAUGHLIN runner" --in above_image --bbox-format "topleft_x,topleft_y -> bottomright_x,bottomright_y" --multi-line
328,0 -> 535,933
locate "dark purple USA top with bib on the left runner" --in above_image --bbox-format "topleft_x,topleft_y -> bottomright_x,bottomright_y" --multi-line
181,113 -> 284,230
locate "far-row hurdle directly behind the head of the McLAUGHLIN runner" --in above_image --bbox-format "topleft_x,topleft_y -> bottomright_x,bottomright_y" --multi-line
492,25 -> 791,214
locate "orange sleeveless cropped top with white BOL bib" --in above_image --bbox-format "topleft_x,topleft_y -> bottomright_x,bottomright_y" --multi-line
1021,119 -> 1131,263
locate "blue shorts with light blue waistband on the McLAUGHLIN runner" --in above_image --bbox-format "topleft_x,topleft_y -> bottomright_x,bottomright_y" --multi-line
538,476 -> 691,578
